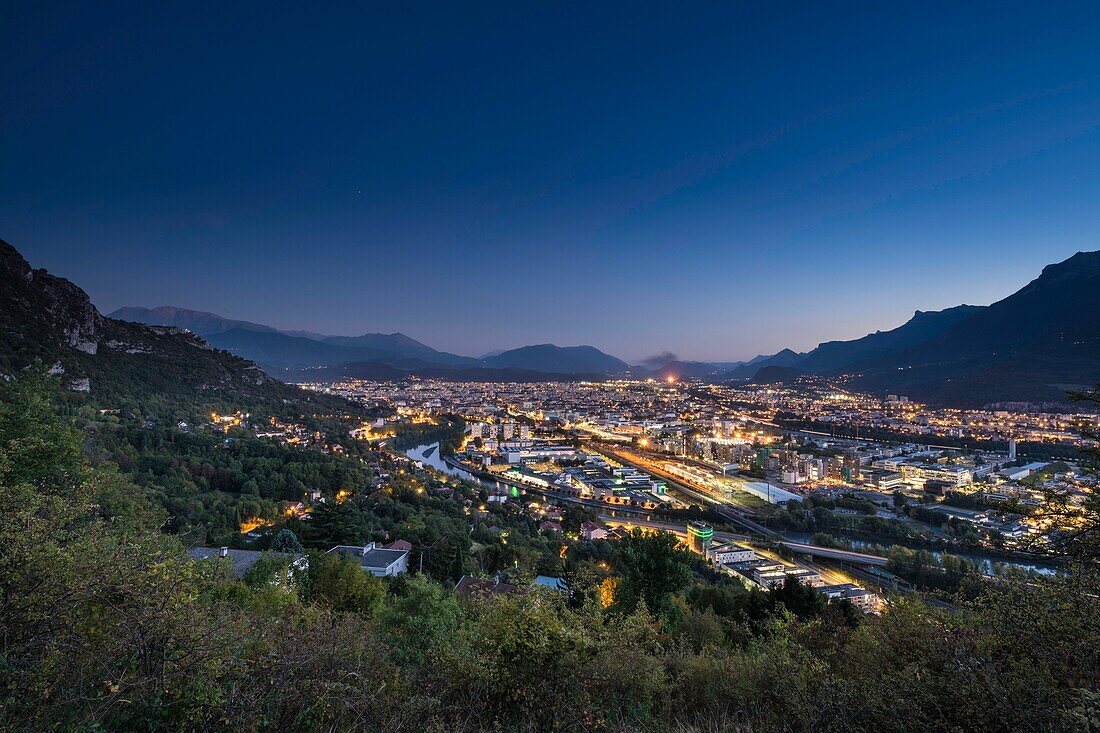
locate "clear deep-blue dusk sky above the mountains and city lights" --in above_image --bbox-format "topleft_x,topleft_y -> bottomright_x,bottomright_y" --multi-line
0,2 -> 1100,361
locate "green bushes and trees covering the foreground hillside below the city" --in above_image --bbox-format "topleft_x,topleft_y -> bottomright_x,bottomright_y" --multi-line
0,378 -> 1100,732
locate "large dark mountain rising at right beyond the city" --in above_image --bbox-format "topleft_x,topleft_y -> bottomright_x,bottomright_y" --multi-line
719,252 -> 1100,406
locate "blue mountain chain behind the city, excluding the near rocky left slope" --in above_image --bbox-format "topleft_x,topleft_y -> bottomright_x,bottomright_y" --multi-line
96,252 -> 1100,406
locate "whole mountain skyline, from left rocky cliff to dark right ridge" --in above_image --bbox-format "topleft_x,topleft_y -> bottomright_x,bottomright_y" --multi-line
0,234 -> 1100,406
